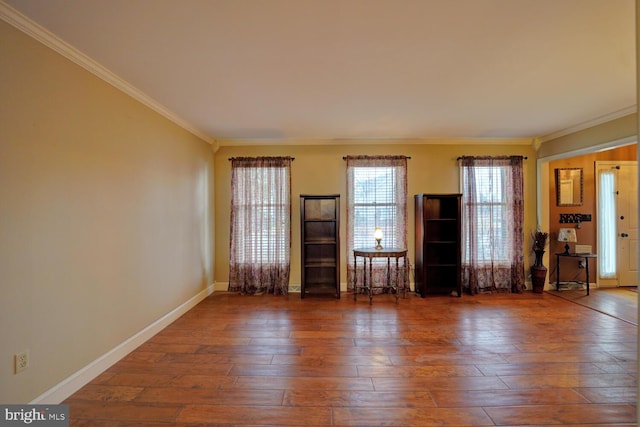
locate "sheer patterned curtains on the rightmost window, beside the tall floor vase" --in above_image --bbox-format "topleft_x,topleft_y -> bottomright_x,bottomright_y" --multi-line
461,156 -> 524,294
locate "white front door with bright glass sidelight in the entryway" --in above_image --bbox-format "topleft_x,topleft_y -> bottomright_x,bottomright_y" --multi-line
596,161 -> 638,286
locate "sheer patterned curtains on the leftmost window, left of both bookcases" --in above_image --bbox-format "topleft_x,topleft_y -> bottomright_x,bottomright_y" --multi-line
229,157 -> 292,295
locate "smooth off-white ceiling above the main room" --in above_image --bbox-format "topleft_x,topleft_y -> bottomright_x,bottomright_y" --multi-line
5,0 -> 636,144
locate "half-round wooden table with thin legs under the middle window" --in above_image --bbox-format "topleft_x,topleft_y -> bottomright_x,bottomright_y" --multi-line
353,248 -> 409,304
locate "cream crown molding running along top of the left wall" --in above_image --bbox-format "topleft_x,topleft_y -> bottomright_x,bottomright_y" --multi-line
0,0 -> 212,144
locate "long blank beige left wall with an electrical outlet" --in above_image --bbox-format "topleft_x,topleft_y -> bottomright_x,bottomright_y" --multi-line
0,21 -> 213,403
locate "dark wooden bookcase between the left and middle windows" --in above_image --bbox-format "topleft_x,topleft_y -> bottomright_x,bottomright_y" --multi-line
300,194 -> 340,298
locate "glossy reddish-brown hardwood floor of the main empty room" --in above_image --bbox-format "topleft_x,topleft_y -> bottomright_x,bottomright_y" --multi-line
65,292 -> 637,427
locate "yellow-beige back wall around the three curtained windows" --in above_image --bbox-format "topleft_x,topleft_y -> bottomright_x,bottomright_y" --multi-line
215,141 -> 536,289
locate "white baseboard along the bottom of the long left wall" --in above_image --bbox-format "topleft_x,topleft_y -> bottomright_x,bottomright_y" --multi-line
29,285 -> 214,404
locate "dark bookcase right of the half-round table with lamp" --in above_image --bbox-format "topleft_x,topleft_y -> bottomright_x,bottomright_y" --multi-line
414,194 -> 462,297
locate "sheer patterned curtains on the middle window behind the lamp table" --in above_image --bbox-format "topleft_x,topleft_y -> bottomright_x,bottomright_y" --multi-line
346,156 -> 408,292
